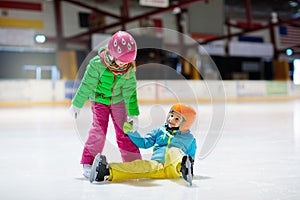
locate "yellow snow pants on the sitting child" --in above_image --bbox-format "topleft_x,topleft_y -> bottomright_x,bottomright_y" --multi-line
107,147 -> 184,182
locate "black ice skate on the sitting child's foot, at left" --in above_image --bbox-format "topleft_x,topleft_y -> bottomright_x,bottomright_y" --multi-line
90,153 -> 109,183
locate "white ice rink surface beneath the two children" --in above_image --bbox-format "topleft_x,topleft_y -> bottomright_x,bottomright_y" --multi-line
0,101 -> 300,200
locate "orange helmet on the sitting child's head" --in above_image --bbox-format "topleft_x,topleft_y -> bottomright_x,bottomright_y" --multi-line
169,103 -> 196,132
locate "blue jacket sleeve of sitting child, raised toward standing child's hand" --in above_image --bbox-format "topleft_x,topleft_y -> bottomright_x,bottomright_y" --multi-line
127,130 -> 157,149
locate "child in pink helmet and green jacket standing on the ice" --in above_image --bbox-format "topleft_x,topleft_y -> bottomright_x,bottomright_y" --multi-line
70,31 -> 141,178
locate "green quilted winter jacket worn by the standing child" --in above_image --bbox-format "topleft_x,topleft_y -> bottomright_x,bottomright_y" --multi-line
72,49 -> 139,116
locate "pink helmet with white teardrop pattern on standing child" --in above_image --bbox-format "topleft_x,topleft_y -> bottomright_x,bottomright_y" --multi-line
108,31 -> 137,63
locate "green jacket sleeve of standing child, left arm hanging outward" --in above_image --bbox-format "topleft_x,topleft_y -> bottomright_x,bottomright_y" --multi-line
72,57 -> 101,108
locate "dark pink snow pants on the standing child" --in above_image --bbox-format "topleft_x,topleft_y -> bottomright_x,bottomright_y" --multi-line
80,101 -> 142,164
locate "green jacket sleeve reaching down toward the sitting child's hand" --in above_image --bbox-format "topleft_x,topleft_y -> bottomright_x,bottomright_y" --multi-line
122,70 -> 140,116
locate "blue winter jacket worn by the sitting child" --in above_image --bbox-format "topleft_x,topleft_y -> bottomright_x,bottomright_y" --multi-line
127,124 -> 197,163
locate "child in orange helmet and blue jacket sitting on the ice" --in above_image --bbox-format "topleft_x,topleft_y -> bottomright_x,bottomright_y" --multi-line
90,103 -> 197,185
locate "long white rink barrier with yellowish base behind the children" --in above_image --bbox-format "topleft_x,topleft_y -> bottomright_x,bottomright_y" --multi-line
0,80 -> 300,106
